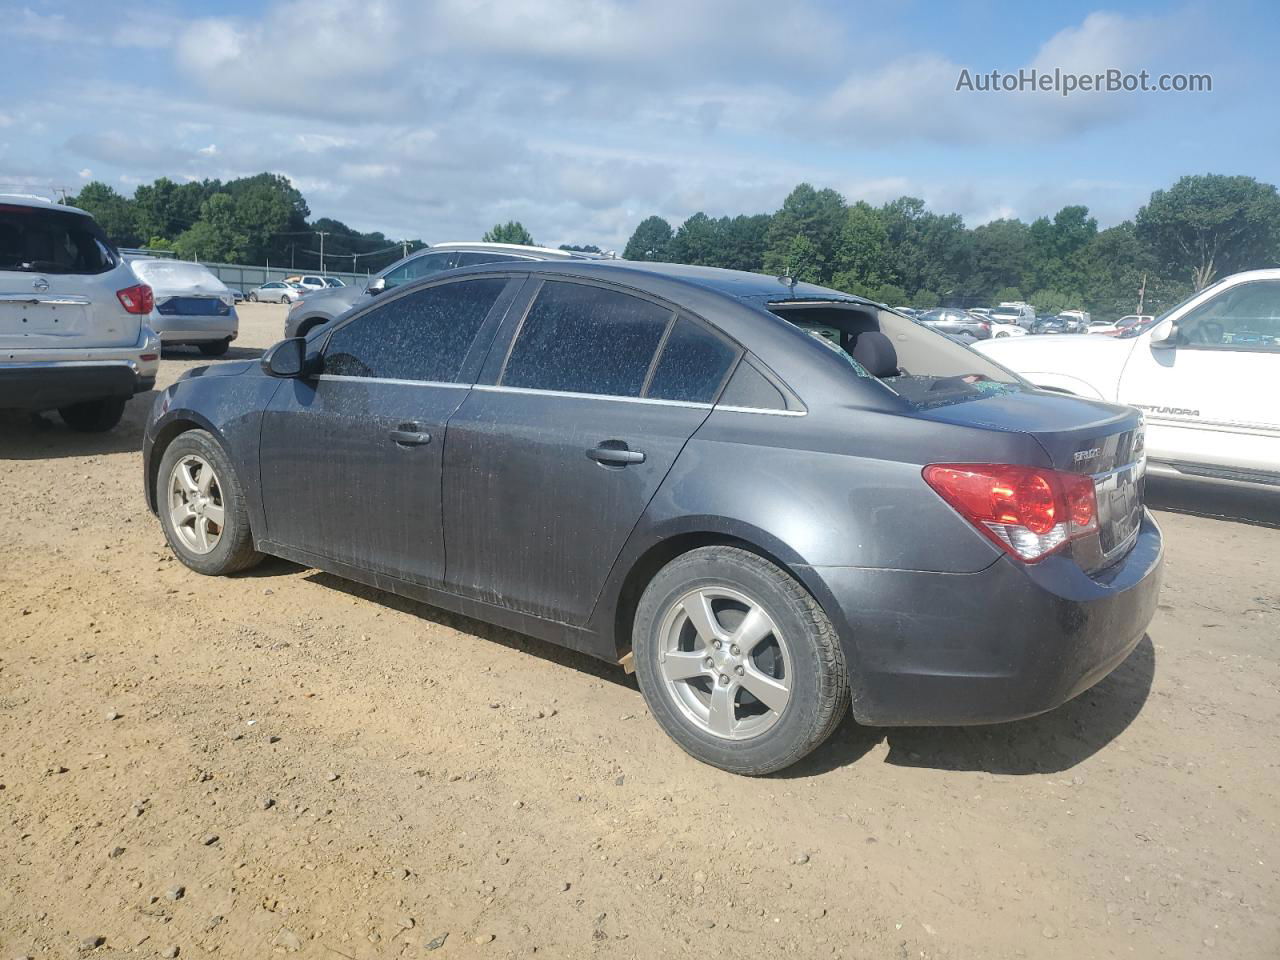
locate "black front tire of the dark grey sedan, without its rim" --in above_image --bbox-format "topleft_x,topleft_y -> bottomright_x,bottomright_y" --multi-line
156,430 -> 262,576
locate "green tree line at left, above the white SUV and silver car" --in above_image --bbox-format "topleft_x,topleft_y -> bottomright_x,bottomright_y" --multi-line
67,173 -> 425,273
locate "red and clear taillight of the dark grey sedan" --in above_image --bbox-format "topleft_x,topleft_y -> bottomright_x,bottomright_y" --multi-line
924,463 -> 1098,562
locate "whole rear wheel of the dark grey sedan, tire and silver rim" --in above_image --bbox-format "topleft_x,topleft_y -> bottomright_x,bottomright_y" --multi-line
632,547 -> 849,776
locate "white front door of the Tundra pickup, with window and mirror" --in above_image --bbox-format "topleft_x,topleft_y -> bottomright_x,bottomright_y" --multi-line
1119,280 -> 1280,480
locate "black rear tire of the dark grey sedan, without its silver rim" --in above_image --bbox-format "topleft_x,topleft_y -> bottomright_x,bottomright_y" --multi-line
632,547 -> 849,776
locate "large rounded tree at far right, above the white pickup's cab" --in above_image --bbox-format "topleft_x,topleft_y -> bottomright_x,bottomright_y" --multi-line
1135,174 -> 1280,289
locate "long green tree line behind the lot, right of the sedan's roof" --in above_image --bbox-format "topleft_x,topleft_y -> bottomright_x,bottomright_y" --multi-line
622,174 -> 1280,317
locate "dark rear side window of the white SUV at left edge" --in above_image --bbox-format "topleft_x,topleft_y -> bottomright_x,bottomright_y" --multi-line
0,204 -> 119,274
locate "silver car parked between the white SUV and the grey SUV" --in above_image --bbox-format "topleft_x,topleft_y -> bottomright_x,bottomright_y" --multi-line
129,257 -> 239,357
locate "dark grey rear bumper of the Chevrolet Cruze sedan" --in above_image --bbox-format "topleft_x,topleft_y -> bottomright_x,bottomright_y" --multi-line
809,511 -> 1164,726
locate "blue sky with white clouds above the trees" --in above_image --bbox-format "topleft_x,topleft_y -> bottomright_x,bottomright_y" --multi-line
0,0 -> 1280,247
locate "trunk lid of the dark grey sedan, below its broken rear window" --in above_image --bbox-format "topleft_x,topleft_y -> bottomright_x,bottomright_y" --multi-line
918,390 -> 1147,570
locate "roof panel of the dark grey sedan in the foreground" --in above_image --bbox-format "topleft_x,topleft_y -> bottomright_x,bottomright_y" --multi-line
448,260 -> 888,310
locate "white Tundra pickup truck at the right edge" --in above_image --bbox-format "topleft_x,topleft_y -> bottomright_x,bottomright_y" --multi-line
973,270 -> 1280,492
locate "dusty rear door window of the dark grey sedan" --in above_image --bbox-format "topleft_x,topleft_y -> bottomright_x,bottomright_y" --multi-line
502,282 -> 671,397
